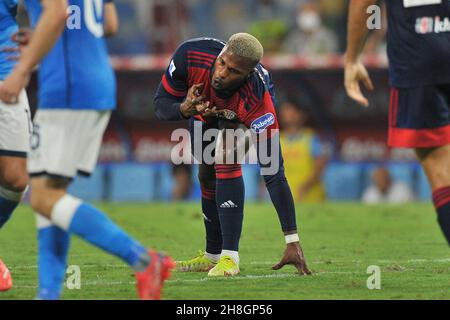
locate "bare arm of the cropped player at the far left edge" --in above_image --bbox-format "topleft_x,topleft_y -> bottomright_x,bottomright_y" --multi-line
0,0 -> 67,104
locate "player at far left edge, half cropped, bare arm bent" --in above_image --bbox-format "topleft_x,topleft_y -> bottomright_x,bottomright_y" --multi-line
0,0 -> 67,291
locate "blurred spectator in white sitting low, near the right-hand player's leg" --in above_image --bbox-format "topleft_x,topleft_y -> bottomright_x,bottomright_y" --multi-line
362,167 -> 414,204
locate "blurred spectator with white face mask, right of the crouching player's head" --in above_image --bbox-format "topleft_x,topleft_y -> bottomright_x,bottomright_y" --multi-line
283,2 -> 338,55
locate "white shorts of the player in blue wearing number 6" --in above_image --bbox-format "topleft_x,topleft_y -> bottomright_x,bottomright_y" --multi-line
28,109 -> 111,178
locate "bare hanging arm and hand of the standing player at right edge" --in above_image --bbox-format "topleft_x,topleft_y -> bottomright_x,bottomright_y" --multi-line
344,0 -> 377,107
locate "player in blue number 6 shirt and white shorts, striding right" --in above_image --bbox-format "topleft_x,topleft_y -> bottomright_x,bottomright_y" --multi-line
9,0 -> 174,299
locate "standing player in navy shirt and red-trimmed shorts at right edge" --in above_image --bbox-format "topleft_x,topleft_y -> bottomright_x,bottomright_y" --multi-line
345,0 -> 450,244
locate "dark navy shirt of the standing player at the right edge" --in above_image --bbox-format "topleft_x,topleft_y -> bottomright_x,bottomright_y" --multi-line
386,0 -> 450,88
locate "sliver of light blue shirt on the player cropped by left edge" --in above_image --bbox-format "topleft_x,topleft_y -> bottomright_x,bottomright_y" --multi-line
0,0 -> 18,80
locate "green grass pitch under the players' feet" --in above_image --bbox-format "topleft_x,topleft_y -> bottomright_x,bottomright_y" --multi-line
0,203 -> 450,300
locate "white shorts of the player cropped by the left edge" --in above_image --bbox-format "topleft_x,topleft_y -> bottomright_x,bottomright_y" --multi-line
0,90 -> 33,158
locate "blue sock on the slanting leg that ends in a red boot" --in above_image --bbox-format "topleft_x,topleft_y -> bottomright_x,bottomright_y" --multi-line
68,203 -> 147,268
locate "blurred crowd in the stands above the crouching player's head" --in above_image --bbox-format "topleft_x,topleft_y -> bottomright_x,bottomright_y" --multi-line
105,0 -> 383,55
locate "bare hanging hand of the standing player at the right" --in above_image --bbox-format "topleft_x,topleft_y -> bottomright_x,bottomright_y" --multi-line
345,62 -> 374,107
